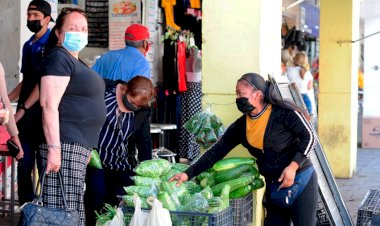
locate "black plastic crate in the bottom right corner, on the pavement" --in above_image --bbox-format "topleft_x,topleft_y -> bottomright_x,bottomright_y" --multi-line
356,189 -> 380,226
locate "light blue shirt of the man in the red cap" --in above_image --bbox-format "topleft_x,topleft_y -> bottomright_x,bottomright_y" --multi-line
92,46 -> 150,82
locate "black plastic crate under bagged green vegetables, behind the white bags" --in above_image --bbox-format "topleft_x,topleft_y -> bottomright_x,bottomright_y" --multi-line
123,207 -> 232,226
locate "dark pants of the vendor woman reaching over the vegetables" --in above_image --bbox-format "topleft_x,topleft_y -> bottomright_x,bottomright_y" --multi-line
264,171 -> 318,226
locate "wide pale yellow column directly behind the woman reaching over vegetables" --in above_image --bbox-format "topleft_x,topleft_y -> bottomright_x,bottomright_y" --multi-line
202,0 -> 282,225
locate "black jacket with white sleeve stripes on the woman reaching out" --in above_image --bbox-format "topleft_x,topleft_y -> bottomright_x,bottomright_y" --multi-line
185,105 -> 316,180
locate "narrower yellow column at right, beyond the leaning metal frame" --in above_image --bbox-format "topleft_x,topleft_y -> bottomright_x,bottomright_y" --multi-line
318,0 -> 360,178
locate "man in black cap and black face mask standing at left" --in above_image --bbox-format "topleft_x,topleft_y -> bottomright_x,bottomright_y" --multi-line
9,0 -> 53,205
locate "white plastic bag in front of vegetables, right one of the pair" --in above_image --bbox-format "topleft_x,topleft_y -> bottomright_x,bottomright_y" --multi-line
144,197 -> 172,226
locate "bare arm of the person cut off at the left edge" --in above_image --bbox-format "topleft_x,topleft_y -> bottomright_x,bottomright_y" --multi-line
0,62 -> 24,160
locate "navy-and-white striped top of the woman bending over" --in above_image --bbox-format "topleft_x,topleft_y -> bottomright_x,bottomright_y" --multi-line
99,88 -> 135,171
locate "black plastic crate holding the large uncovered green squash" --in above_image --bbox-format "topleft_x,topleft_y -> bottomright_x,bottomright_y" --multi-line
230,193 -> 253,226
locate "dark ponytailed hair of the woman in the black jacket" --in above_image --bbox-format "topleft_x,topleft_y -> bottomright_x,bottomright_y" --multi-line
238,73 -> 310,120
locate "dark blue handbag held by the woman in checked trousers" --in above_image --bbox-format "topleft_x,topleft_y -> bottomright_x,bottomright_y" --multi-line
18,167 -> 79,226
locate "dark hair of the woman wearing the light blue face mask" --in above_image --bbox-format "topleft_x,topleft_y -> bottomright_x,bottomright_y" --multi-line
45,7 -> 87,52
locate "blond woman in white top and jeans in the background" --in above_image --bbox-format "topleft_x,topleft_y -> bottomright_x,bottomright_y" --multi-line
287,52 -> 316,115
